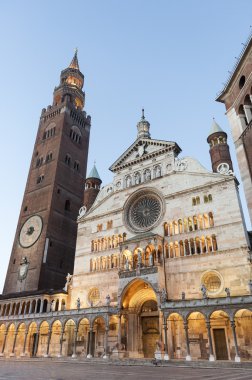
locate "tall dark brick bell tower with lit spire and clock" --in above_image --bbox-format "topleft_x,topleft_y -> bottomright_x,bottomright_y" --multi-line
3,50 -> 91,294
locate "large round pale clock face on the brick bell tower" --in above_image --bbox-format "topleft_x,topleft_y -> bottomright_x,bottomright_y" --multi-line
19,215 -> 43,248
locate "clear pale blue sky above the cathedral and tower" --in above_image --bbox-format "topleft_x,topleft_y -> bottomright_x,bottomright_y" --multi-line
0,0 -> 252,288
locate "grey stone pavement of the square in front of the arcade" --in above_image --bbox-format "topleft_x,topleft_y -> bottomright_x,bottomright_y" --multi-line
0,359 -> 252,380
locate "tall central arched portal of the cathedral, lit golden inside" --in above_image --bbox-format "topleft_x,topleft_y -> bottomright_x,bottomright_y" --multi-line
121,279 -> 160,358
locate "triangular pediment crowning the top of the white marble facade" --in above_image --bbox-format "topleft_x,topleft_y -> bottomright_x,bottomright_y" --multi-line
109,138 -> 181,173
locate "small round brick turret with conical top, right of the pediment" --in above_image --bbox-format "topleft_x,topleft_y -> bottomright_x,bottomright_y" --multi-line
207,119 -> 233,173
